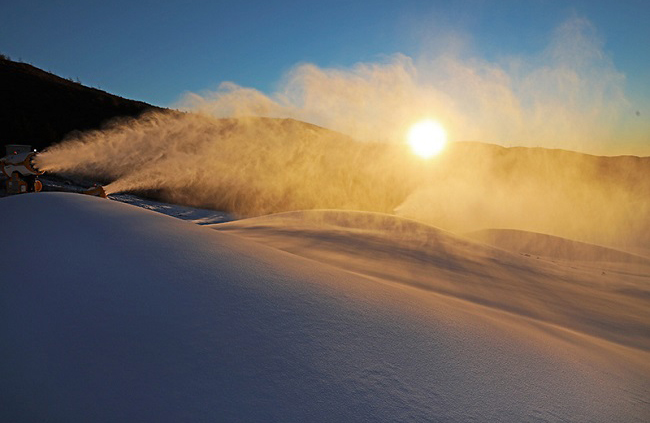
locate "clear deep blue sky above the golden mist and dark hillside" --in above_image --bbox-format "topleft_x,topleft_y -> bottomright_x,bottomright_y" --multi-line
0,0 -> 650,106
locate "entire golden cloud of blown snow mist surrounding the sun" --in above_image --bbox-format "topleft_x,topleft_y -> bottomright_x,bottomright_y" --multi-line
37,19 -> 650,252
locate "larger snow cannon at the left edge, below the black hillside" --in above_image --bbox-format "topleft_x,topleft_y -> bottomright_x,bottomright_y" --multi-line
0,144 -> 43,194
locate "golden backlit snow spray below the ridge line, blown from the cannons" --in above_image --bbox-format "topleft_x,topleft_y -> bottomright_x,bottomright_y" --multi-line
38,112 -> 650,252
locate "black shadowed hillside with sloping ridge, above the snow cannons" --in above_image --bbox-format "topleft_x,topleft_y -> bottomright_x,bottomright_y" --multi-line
0,56 -> 161,150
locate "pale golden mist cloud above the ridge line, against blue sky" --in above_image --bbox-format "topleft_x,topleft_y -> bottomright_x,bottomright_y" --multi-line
178,18 -> 650,154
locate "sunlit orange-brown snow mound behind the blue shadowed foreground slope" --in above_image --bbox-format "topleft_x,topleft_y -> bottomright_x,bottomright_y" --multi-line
211,210 -> 650,351
